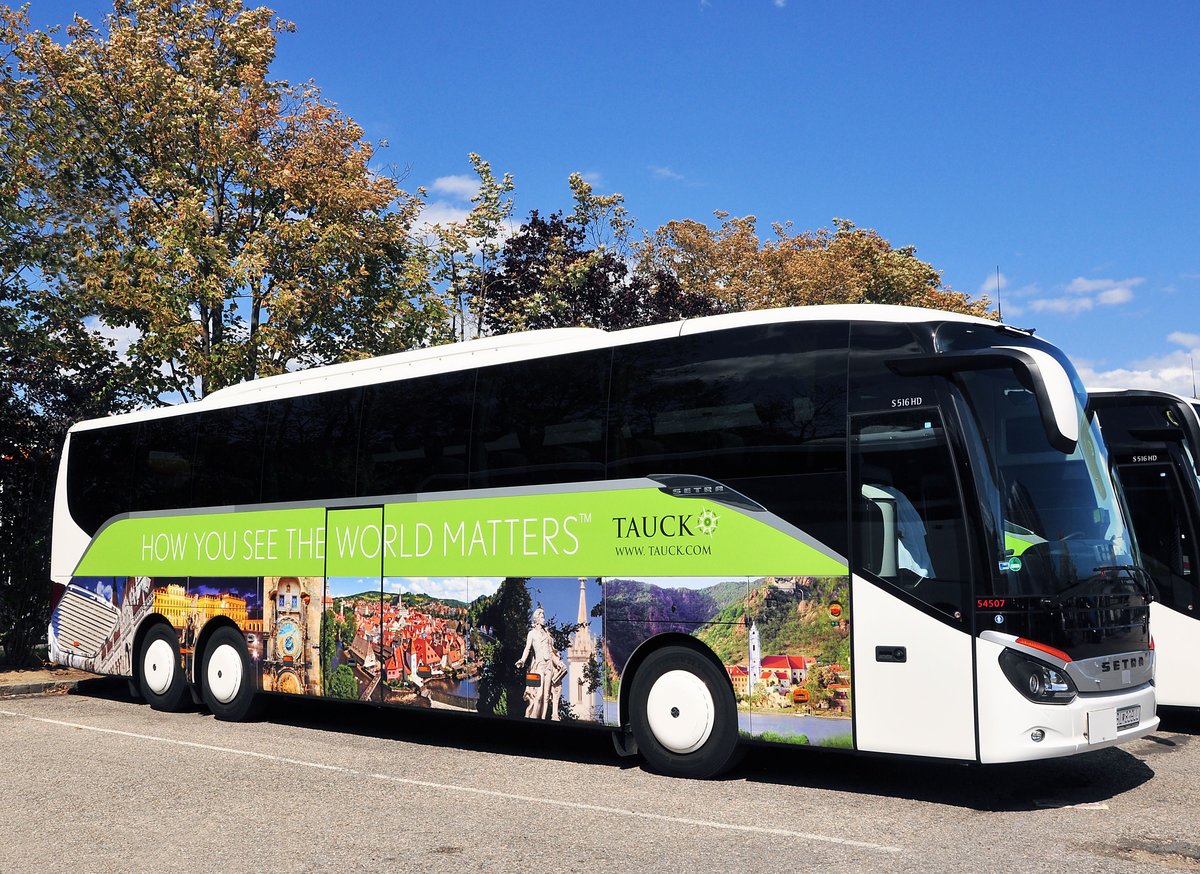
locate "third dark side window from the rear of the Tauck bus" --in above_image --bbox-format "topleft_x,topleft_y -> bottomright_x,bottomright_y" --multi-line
192,403 -> 266,507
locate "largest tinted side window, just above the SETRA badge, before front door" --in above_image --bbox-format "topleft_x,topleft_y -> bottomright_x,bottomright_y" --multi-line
608,323 -> 848,553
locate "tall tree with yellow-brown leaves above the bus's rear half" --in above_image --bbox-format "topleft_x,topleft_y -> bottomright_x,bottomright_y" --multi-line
0,0 -> 449,399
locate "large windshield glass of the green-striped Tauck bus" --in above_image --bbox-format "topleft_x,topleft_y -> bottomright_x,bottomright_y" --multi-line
938,325 -> 1135,597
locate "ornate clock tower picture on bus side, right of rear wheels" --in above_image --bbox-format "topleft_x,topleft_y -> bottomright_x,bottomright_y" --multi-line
263,576 -> 320,695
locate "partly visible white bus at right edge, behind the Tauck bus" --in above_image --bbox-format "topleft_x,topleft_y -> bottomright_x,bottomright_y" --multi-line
1088,389 -> 1200,707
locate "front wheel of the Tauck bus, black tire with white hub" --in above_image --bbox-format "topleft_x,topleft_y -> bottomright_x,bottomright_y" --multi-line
629,646 -> 739,779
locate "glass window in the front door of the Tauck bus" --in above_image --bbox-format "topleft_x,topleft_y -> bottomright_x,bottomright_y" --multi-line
851,407 -> 968,615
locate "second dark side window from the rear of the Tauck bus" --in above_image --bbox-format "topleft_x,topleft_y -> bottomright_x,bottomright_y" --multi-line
132,415 -> 196,510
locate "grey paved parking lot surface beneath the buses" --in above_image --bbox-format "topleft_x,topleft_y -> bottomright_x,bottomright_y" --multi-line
0,680 -> 1200,874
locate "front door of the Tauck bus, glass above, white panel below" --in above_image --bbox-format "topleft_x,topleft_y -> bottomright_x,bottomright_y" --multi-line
851,406 -> 976,760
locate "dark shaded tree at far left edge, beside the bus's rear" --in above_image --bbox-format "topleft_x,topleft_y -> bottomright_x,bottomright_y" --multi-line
0,23 -> 144,664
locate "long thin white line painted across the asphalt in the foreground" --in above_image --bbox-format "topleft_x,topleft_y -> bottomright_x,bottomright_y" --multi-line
0,711 -> 902,852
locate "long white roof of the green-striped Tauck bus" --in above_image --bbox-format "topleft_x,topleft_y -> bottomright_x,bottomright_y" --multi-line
71,304 -> 1001,431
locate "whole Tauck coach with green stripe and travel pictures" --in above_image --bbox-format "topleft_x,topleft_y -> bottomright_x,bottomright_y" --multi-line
49,306 -> 1158,776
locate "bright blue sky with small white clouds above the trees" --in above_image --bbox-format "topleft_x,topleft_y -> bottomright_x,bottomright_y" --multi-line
31,0 -> 1200,394
